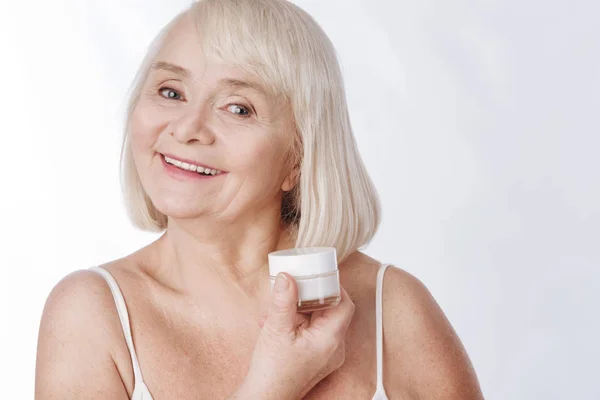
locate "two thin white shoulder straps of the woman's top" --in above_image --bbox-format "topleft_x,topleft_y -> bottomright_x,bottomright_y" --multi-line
90,264 -> 389,400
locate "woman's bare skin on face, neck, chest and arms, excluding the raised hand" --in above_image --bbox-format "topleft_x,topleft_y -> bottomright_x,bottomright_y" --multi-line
36,10 -> 483,400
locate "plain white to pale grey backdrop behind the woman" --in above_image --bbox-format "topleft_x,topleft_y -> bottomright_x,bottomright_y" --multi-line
0,0 -> 600,400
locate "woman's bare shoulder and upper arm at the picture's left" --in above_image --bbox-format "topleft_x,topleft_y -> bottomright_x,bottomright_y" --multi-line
35,271 -> 129,400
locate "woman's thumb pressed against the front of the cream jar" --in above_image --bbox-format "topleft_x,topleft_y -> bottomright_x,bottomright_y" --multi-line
265,272 -> 298,335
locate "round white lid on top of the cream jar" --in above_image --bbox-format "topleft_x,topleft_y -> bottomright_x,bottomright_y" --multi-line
269,247 -> 338,276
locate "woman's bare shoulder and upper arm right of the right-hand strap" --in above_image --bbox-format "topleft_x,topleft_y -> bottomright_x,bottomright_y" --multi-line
383,268 -> 483,400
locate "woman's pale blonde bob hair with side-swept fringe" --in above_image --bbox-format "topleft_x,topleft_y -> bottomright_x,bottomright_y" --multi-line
121,0 -> 381,262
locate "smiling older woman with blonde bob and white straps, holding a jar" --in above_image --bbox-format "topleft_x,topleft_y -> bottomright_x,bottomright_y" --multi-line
36,0 -> 482,400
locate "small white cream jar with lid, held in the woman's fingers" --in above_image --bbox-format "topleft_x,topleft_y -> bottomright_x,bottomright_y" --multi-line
268,247 -> 341,312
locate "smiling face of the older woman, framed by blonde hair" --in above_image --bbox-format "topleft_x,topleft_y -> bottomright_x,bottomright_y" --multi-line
130,16 -> 294,223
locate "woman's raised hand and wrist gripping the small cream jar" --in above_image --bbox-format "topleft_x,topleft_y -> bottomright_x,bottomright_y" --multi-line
234,272 -> 355,400
